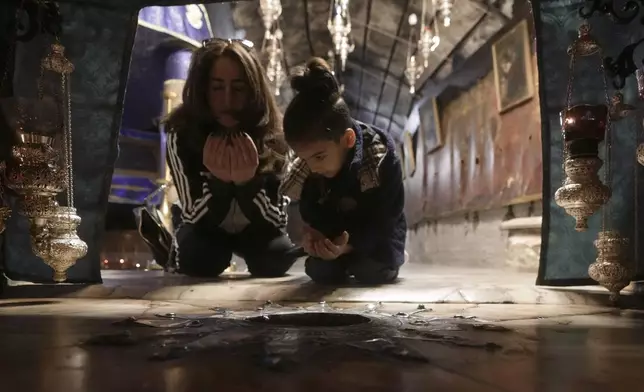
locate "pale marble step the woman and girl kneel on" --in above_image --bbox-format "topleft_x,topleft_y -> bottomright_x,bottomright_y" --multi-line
5,263 -> 639,306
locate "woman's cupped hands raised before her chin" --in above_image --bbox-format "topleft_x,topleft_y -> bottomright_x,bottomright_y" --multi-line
203,133 -> 259,184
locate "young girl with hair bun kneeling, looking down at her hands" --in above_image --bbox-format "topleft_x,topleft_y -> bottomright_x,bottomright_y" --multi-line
280,59 -> 407,284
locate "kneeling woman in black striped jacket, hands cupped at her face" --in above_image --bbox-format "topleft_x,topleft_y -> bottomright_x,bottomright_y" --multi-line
166,39 -> 297,277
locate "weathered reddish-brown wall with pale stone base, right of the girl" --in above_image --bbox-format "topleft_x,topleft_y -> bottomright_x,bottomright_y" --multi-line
401,18 -> 543,272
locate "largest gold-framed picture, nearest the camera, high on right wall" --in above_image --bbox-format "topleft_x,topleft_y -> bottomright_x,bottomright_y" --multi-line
492,19 -> 534,113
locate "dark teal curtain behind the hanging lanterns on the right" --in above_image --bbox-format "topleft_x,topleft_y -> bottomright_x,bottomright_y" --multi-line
532,0 -> 644,285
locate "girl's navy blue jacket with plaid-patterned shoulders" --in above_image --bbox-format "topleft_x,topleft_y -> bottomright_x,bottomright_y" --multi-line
280,122 -> 407,266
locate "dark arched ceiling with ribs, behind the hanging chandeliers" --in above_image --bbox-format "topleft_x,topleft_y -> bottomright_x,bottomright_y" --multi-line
233,0 -> 514,134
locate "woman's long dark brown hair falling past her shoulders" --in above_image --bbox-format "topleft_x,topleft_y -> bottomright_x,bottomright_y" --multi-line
165,39 -> 286,171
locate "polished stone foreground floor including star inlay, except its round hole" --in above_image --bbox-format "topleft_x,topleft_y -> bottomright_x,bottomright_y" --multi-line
0,298 -> 644,392
